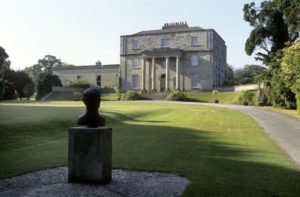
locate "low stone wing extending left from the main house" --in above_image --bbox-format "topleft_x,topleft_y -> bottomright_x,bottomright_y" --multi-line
53,64 -> 120,87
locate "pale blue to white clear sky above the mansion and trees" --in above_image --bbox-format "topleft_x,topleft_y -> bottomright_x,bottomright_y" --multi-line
0,0 -> 261,69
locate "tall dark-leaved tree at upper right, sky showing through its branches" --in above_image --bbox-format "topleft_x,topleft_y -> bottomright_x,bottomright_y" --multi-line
244,0 -> 300,64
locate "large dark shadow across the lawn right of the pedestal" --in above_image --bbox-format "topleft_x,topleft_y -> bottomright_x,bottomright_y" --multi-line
108,113 -> 300,196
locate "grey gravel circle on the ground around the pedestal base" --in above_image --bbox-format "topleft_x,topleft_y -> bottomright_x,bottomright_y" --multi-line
0,167 -> 189,197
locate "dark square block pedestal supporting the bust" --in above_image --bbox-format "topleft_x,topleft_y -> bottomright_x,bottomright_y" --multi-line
68,127 -> 112,184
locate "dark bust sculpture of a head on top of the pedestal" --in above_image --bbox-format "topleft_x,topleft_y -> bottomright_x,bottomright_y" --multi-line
77,88 -> 105,127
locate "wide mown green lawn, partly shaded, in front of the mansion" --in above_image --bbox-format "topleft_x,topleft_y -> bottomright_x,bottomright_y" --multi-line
0,102 -> 300,196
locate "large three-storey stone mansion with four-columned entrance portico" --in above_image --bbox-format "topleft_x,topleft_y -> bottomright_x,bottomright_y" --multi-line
120,23 -> 226,92
